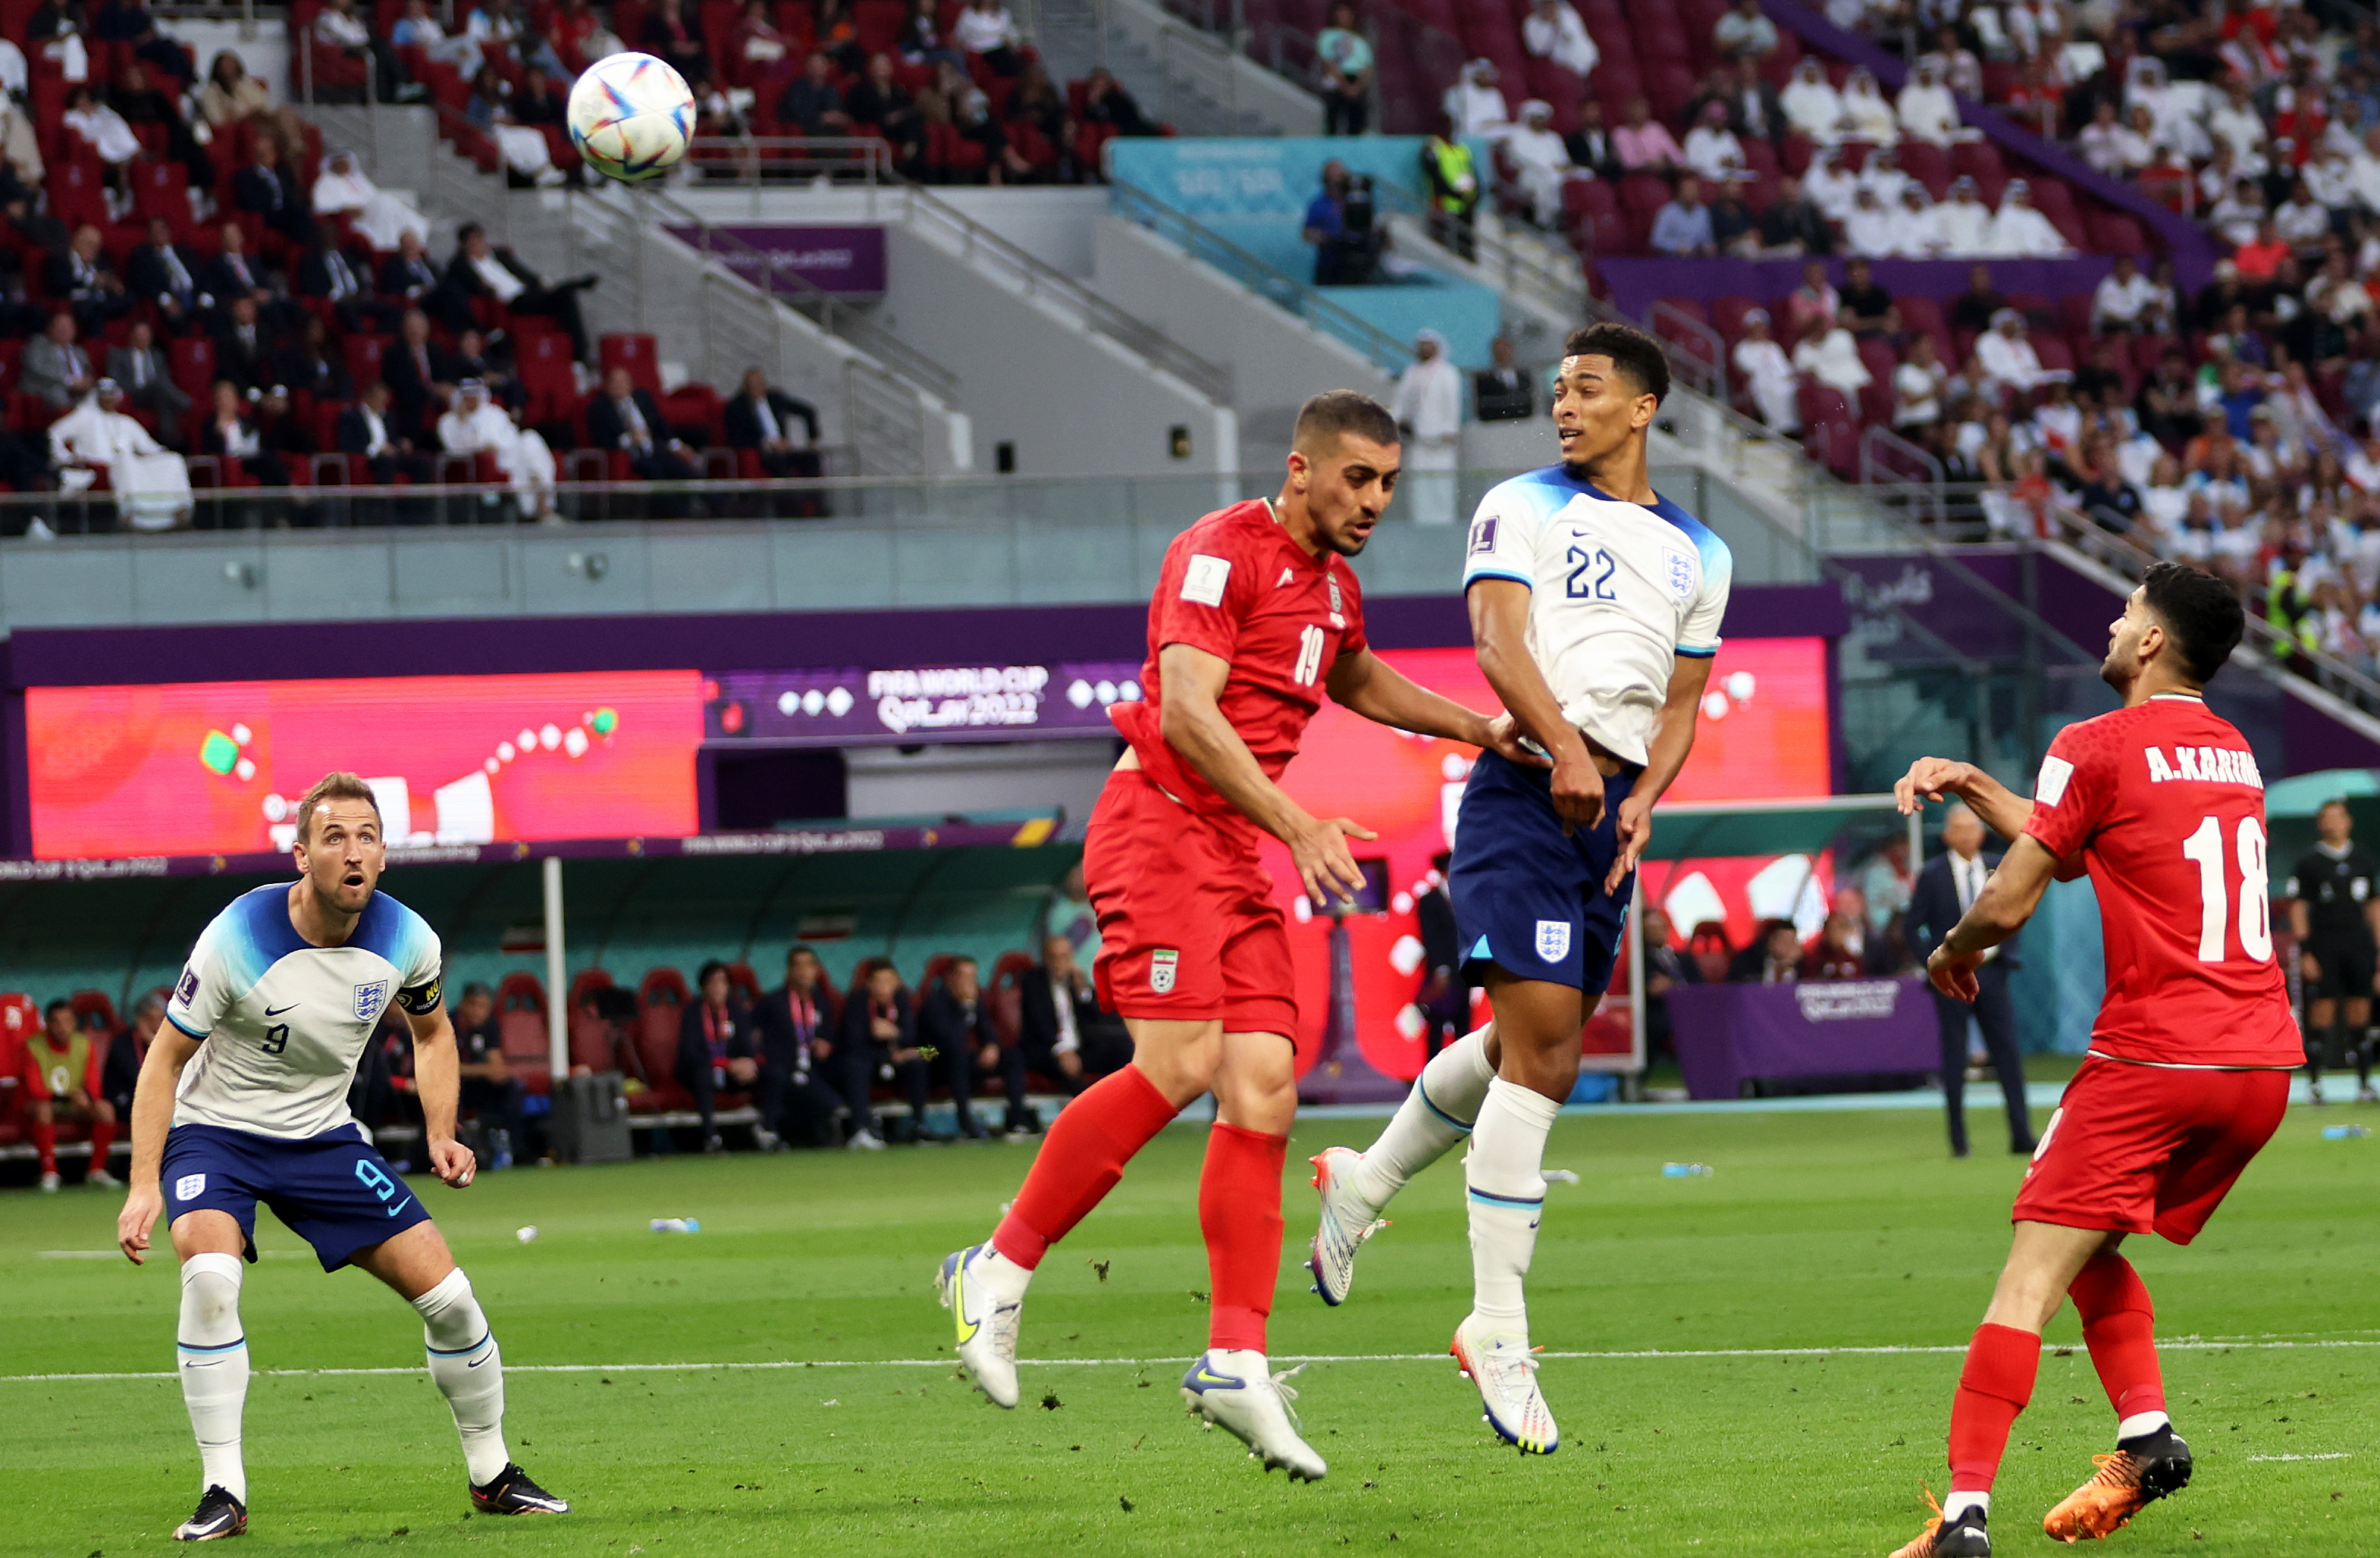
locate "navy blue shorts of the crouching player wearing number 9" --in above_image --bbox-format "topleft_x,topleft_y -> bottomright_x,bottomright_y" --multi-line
159,1123 -> 431,1270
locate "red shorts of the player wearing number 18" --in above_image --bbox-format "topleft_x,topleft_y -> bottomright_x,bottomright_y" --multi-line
2011,1056 -> 2290,1244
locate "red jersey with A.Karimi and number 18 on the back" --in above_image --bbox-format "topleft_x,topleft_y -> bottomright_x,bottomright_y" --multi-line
2025,692 -> 2304,1066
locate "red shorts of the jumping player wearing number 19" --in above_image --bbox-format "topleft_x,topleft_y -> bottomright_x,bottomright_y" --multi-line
1083,768 -> 1297,1039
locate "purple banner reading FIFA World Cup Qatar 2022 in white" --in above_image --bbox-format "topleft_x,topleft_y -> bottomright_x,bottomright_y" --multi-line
702,659 -> 1140,747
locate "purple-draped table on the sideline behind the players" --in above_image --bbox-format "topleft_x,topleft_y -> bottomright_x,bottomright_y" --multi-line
1666,980 -> 1942,1099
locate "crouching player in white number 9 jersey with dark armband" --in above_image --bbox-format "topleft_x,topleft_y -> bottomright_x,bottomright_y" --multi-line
117,773 -> 569,1541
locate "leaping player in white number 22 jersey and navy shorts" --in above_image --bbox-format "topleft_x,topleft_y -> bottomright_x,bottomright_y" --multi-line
1312,324 -> 1732,1456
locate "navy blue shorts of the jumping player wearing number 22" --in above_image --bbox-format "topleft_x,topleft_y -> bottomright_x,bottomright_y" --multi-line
1447,751 -> 1640,997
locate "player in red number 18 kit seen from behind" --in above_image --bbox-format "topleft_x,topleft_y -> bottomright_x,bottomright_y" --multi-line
1895,564 -> 2301,1558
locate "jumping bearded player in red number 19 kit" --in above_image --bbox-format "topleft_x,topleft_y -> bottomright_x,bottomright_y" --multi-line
936,390 -> 1533,1479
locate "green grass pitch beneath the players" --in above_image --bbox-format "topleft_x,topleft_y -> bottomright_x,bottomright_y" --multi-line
0,1108 -> 2380,1558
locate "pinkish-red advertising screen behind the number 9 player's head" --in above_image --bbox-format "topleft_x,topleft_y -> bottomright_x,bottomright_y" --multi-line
27,671 -> 702,859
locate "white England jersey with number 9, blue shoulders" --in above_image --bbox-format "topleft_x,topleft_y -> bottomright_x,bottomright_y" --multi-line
165,882 -> 438,1140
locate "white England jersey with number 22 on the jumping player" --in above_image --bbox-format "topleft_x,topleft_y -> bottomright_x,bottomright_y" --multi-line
1463,466 -> 1735,763
